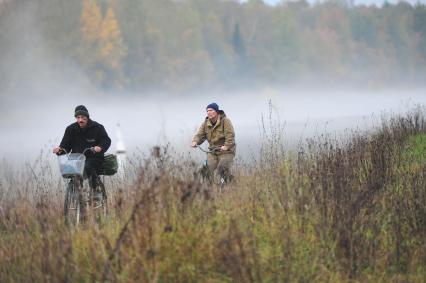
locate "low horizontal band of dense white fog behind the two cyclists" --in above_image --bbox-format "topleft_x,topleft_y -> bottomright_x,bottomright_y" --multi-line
0,87 -> 426,163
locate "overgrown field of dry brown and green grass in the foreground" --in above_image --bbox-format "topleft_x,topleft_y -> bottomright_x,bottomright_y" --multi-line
0,108 -> 426,282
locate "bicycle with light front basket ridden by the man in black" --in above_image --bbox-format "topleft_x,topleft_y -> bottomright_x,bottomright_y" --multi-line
58,148 -> 108,226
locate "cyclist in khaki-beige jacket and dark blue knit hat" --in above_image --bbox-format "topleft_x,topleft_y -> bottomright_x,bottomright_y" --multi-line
191,103 -> 235,181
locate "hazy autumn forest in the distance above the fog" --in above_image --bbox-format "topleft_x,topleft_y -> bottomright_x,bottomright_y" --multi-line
0,0 -> 426,92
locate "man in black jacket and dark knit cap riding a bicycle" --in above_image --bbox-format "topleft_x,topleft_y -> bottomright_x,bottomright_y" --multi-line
53,105 -> 111,189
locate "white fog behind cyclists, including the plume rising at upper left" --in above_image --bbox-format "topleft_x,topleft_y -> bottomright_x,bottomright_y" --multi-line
0,0 -> 426,166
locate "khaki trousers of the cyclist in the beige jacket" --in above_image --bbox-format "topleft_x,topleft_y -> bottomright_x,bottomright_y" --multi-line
207,153 -> 234,182
